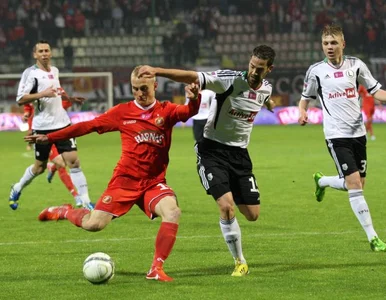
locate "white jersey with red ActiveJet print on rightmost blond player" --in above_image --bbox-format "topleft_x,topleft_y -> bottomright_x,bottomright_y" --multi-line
301,56 -> 381,139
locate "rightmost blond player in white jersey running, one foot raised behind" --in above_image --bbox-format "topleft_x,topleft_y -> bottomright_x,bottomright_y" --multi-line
299,25 -> 386,251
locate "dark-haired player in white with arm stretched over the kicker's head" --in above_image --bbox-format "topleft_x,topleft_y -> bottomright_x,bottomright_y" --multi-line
139,45 -> 275,276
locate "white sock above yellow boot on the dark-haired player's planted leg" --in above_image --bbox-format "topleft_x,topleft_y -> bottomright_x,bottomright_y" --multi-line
220,217 -> 246,263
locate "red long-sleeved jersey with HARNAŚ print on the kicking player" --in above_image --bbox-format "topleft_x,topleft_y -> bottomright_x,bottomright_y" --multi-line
47,101 -> 200,189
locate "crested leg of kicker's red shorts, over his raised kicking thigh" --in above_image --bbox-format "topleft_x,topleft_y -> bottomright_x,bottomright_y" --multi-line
94,188 -> 142,218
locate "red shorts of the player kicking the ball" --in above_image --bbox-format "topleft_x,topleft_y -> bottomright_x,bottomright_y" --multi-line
95,183 -> 176,219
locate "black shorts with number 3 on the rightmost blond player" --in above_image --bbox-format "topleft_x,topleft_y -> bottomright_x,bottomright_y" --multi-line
326,135 -> 367,177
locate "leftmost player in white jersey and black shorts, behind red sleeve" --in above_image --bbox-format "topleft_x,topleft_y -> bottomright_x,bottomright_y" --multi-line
9,41 -> 90,210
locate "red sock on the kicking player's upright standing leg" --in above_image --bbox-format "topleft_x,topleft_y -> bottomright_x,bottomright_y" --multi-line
152,222 -> 178,267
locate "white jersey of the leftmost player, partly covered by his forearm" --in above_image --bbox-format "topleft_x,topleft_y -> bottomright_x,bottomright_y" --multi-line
16,65 -> 71,130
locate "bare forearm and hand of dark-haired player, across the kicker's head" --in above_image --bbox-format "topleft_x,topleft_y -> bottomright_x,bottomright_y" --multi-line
138,65 -> 199,84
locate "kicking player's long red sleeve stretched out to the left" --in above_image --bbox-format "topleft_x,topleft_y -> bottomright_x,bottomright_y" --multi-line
47,104 -> 121,143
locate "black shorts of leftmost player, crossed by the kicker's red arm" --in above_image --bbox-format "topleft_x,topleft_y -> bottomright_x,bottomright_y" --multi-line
32,126 -> 77,161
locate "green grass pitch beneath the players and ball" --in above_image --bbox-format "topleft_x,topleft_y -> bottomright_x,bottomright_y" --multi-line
0,125 -> 386,300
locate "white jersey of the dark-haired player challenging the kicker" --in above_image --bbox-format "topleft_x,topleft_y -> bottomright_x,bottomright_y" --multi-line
198,70 -> 272,148
